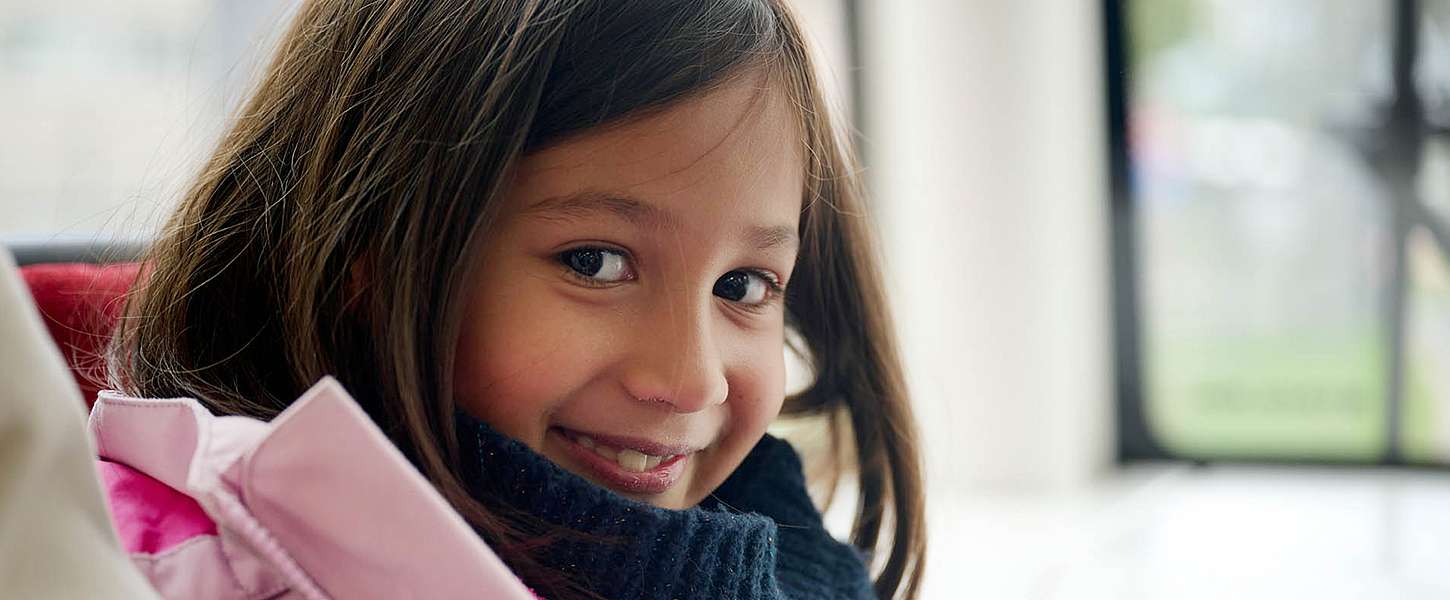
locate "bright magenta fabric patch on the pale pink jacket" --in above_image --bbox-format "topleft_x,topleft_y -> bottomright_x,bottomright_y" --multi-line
97,459 -> 216,554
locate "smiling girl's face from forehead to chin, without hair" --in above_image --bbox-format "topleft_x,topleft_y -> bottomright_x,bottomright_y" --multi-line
454,77 -> 805,509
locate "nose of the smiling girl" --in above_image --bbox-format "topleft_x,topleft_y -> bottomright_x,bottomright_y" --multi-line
622,294 -> 729,413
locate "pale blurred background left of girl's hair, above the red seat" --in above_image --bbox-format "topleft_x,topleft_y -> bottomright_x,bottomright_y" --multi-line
0,0 -> 296,239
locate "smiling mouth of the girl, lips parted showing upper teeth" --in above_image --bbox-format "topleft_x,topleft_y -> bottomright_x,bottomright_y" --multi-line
550,428 -> 697,494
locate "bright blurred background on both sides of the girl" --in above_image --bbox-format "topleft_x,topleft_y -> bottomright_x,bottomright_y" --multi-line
8,0 -> 1450,600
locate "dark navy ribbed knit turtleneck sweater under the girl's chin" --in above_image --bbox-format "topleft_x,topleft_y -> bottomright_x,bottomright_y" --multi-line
457,413 -> 874,600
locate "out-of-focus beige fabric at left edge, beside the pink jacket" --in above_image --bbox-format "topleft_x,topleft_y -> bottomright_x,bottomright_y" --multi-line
0,249 -> 157,599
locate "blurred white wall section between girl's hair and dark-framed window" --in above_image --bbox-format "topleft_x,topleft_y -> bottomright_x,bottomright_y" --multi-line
861,0 -> 1112,496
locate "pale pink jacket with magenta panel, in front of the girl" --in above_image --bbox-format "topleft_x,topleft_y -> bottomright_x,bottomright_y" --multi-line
90,378 -> 545,600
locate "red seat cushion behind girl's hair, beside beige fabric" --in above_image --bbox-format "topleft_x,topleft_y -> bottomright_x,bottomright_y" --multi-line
20,262 -> 141,407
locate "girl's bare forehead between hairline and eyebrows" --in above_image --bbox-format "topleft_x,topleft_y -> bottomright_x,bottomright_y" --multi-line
509,75 -> 805,223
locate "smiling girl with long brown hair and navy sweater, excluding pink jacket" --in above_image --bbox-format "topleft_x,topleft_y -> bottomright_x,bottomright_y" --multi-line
112,0 -> 925,599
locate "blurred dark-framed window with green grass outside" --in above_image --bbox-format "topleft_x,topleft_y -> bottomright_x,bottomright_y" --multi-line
1106,0 -> 1450,464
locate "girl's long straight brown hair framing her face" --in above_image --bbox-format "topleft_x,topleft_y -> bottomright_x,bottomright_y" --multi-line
110,0 -> 925,599
